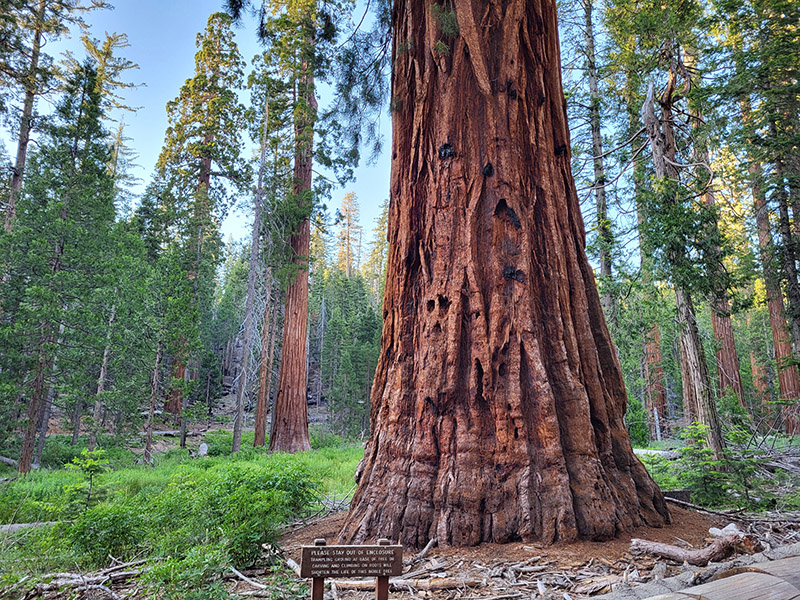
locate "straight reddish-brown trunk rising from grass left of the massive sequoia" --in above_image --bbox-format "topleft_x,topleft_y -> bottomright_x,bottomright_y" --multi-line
269,40 -> 317,452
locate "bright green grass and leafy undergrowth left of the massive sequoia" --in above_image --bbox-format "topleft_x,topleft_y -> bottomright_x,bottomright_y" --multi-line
0,432 -> 363,600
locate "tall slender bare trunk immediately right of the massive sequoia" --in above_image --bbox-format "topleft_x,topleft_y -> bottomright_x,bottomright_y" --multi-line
582,0 -> 616,321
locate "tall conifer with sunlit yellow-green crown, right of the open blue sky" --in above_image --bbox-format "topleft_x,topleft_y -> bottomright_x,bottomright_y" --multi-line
157,13 -> 250,420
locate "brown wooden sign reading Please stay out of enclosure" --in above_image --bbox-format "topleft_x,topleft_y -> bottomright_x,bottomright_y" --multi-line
300,538 -> 403,600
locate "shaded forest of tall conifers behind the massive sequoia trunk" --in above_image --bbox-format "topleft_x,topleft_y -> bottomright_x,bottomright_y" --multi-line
0,0 -> 800,470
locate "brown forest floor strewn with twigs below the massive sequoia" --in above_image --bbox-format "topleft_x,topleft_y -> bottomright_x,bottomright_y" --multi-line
272,505 -> 800,600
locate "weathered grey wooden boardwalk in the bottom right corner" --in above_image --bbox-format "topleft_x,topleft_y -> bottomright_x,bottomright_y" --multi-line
647,556 -> 800,600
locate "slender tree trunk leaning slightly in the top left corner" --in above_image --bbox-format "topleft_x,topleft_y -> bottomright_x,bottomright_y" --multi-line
5,0 -> 47,232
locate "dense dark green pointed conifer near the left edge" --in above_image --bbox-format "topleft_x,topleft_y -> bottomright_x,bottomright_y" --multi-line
4,63 -> 114,473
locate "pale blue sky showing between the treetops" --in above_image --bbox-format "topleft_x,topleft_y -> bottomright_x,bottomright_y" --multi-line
3,0 -> 391,246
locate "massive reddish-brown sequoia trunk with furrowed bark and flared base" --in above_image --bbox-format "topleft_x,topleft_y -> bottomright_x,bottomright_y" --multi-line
340,0 -> 669,547
